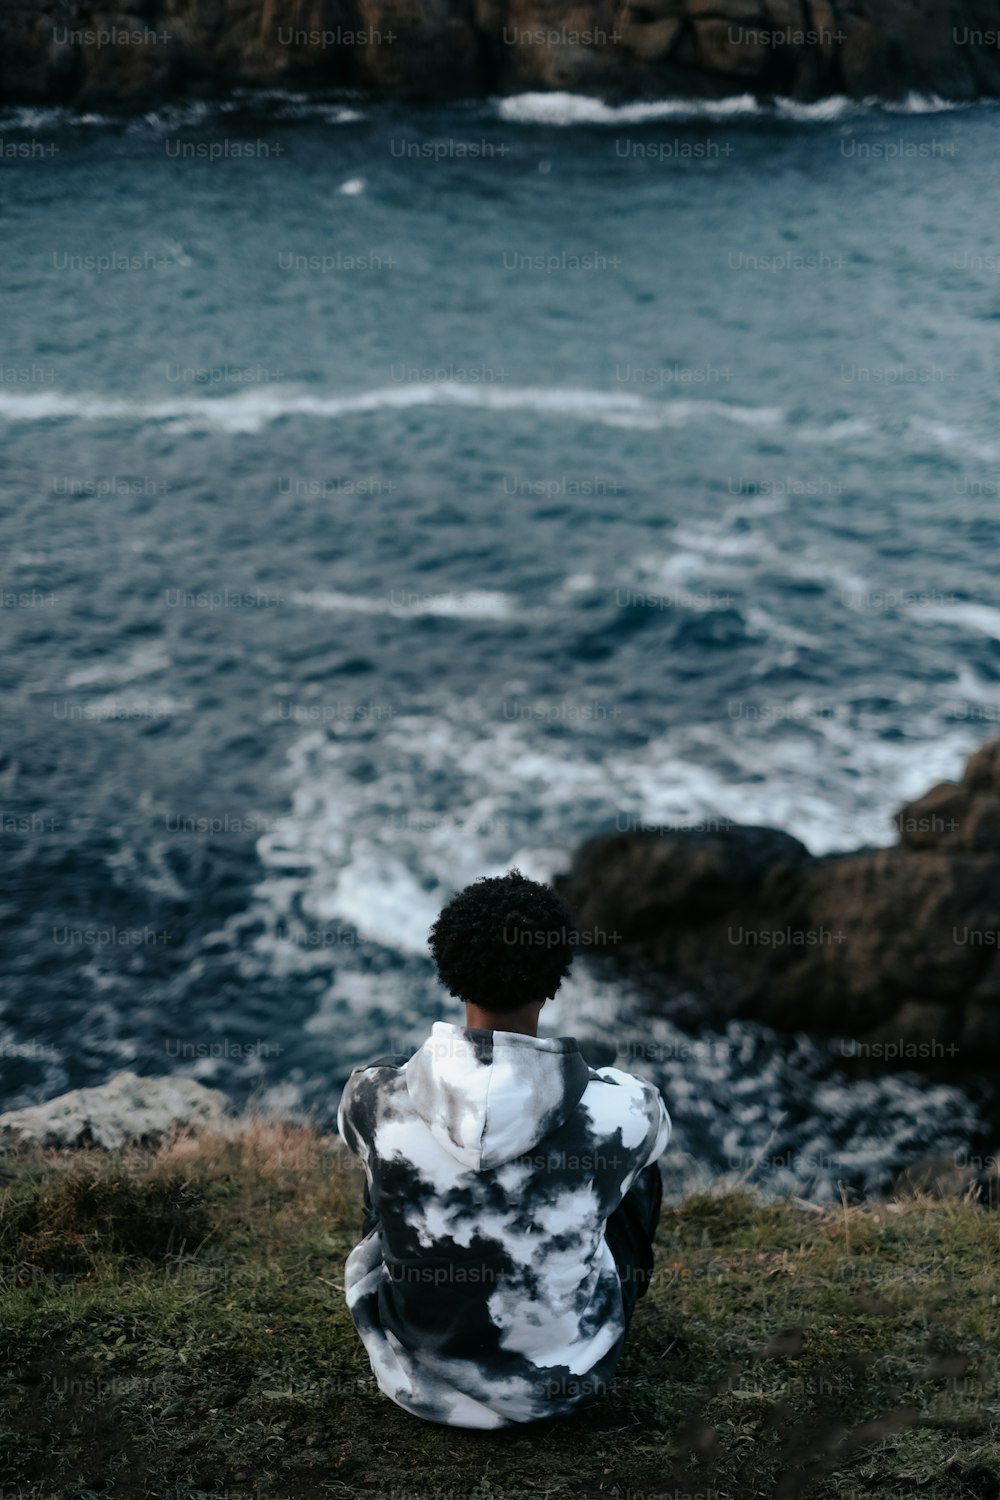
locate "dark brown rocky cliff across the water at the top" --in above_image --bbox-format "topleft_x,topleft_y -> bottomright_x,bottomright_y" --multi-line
0,0 -> 1000,110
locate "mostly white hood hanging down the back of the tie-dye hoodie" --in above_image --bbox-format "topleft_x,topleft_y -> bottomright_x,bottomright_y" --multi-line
403,1022 -> 591,1172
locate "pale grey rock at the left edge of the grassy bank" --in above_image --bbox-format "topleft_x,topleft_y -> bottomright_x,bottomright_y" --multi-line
0,1073 -> 229,1151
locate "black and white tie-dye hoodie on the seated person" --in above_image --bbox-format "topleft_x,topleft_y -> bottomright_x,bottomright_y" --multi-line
337,1022 -> 670,1428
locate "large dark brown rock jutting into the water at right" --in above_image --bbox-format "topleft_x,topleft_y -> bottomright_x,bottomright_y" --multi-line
558,741 -> 1000,1068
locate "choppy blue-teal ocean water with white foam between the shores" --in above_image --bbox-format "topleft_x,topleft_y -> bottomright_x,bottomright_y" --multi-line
0,93 -> 1000,1199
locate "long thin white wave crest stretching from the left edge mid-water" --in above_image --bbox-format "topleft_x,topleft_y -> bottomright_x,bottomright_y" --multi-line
0,380 -> 784,432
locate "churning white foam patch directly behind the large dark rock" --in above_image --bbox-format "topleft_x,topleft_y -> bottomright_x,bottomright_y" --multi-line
236,693 -> 981,965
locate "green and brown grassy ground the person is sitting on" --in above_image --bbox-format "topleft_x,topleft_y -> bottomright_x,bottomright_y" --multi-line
0,1122 -> 1000,1500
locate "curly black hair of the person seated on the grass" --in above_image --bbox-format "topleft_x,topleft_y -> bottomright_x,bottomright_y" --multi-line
429,870 -> 574,1014
